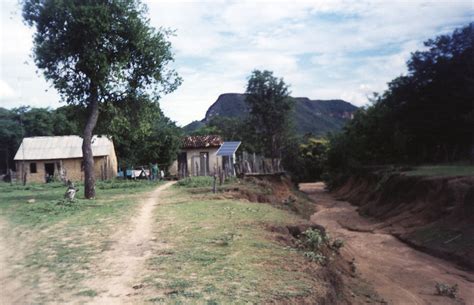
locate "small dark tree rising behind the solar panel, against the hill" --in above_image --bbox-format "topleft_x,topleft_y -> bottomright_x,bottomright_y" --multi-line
245,70 -> 294,159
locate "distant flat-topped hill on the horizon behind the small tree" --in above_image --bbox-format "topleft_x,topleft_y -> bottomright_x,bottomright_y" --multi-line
184,93 -> 358,135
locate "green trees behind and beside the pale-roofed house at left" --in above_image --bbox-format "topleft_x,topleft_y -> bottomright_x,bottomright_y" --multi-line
0,99 -> 183,176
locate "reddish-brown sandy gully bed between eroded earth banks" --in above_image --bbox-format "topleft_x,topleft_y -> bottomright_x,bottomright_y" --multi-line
300,183 -> 474,305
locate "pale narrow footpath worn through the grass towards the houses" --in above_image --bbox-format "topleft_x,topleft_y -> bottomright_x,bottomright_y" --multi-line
86,182 -> 173,305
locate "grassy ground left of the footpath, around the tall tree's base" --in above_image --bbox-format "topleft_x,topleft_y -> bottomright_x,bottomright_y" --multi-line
0,181 -> 163,304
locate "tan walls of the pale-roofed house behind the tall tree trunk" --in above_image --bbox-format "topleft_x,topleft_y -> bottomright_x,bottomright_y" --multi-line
16,153 -> 117,182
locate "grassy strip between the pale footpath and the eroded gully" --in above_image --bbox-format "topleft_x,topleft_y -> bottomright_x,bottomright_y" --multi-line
139,184 -> 321,304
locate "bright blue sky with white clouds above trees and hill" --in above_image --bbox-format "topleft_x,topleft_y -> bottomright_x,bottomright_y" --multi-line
0,0 -> 474,126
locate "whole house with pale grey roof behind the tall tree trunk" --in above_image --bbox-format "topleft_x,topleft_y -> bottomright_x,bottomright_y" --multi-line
14,136 -> 117,182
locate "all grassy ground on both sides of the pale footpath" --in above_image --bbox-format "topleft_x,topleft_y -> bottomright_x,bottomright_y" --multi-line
0,179 -> 330,304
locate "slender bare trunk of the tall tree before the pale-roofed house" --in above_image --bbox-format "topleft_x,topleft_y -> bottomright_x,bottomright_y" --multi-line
82,87 -> 99,199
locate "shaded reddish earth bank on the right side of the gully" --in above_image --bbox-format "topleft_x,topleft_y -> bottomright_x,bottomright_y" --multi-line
334,173 -> 474,270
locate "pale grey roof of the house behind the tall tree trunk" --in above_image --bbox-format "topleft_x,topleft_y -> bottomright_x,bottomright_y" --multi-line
15,136 -> 114,160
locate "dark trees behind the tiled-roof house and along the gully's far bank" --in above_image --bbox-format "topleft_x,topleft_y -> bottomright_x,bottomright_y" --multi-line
191,23 -> 474,182
